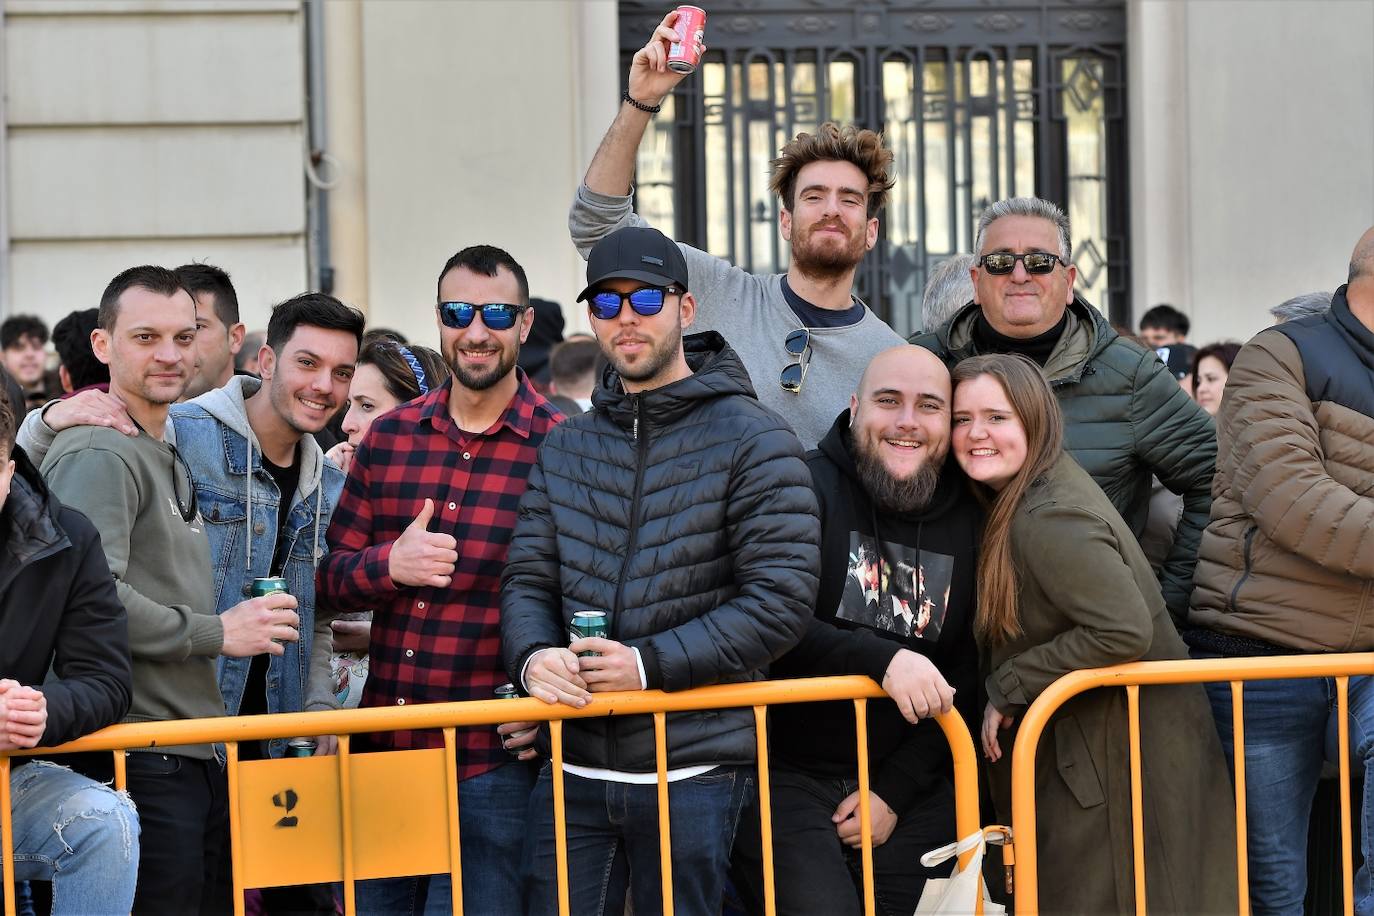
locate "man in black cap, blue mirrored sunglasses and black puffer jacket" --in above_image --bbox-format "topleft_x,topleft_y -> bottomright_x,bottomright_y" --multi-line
502,227 -> 820,915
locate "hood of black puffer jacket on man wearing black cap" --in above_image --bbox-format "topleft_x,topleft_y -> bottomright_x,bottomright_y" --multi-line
592,331 -> 757,428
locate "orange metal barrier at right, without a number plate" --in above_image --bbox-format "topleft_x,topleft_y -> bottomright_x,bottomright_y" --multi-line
1005,654 -> 1374,916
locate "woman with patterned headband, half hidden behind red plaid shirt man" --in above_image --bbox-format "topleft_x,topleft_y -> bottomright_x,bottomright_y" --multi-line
327,336 -> 451,709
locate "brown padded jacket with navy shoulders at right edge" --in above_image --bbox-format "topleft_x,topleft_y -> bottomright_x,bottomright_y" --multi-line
1190,287 -> 1374,652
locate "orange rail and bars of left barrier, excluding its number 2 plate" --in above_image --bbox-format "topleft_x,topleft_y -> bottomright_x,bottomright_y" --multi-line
0,676 -> 981,916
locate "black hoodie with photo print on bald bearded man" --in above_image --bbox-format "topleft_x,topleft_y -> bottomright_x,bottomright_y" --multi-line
768,411 -> 982,816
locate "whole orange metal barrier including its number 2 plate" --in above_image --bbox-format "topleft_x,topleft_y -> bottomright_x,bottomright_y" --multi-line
0,677 -> 980,916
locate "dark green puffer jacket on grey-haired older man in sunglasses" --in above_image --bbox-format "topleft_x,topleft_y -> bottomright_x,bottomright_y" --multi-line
911,297 -> 1216,623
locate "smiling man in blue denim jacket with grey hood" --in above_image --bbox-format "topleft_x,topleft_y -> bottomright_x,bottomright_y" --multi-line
21,293 -> 364,759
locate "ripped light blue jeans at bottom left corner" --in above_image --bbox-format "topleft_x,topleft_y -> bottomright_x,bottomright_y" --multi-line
10,761 -> 139,916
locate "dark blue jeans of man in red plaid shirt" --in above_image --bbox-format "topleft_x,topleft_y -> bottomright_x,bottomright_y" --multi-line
357,762 -> 534,916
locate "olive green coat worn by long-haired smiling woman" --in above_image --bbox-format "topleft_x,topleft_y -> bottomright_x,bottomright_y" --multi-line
984,455 -> 1237,913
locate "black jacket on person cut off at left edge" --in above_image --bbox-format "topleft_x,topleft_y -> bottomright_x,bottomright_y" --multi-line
0,446 -> 133,746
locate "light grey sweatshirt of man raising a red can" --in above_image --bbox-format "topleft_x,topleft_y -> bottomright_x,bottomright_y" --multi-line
567,184 -> 905,449
